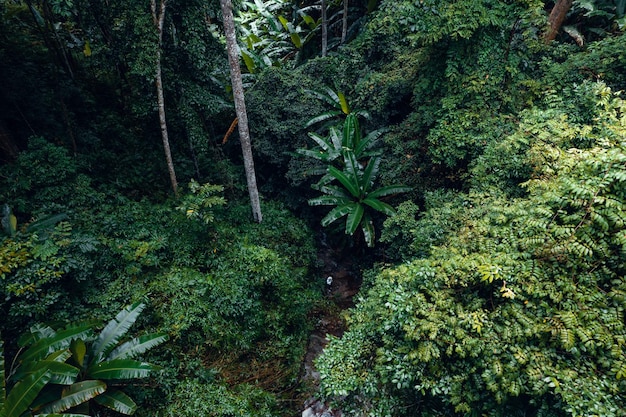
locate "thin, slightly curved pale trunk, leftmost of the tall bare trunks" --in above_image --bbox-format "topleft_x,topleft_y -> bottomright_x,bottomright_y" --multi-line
151,0 -> 178,197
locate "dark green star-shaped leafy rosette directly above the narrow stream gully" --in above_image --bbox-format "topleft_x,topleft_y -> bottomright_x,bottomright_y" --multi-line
309,150 -> 411,247
